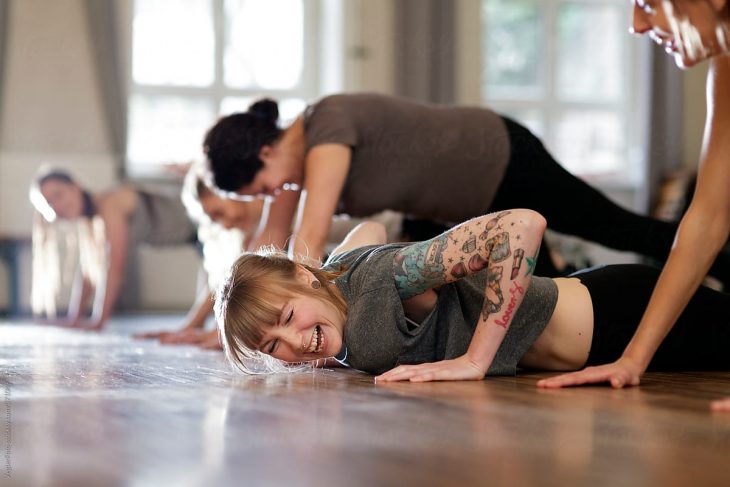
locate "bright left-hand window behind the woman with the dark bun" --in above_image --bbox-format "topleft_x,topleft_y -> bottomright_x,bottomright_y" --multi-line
127,0 -> 319,176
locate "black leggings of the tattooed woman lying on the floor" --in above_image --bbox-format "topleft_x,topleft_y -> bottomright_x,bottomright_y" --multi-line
573,264 -> 730,370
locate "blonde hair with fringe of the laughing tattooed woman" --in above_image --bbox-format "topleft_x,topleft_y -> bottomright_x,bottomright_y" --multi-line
215,247 -> 347,374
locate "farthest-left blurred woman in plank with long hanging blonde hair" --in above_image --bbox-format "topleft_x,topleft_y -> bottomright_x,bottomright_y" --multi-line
30,169 -> 195,330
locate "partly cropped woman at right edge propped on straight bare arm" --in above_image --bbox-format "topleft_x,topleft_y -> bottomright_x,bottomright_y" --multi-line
539,0 -> 730,412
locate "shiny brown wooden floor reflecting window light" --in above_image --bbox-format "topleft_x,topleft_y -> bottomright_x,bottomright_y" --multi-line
0,318 -> 730,487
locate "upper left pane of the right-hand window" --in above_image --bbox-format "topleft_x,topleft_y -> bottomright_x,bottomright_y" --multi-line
482,0 -> 543,98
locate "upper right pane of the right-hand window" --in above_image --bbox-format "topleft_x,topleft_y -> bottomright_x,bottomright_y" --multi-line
557,2 -> 628,102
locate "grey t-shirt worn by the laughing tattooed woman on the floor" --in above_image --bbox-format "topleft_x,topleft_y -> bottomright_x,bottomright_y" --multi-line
325,244 -> 558,375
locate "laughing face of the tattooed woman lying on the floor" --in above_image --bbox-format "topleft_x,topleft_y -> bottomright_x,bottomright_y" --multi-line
258,269 -> 345,362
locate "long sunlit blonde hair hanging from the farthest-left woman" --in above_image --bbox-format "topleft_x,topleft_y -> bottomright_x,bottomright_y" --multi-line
29,173 -> 107,318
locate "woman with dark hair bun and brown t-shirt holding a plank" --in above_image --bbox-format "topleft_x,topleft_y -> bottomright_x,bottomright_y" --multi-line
204,94 -> 730,281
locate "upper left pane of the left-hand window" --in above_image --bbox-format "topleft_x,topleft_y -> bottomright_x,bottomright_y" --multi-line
132,0 -> 215,86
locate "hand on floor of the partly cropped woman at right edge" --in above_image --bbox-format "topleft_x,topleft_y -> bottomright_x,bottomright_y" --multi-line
537,357 -> 644,389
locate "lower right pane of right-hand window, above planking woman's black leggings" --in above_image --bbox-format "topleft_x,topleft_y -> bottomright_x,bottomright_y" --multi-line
555,110 -> 627,179
